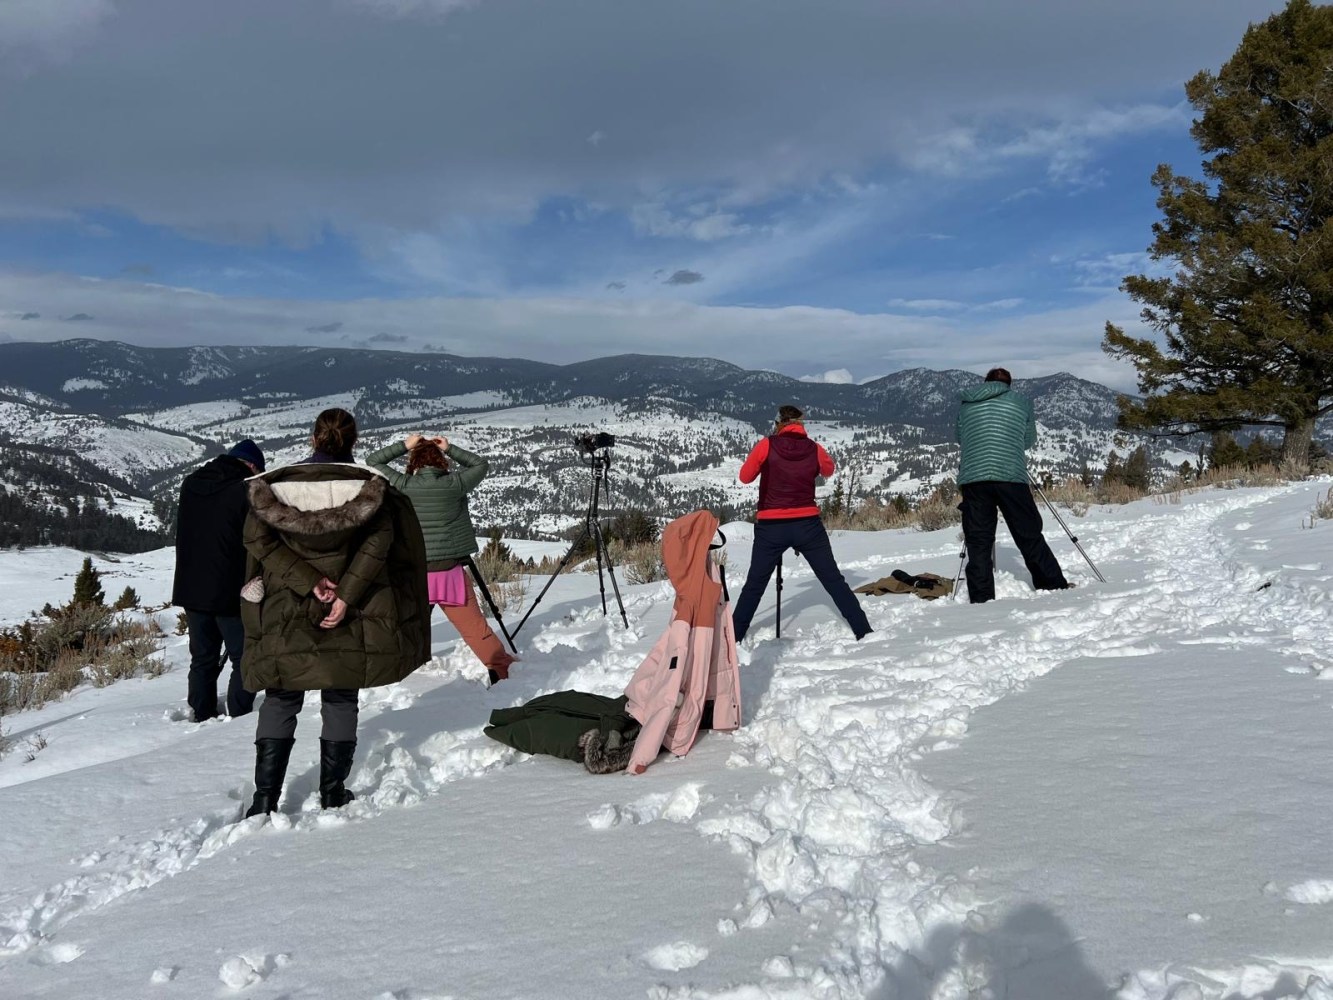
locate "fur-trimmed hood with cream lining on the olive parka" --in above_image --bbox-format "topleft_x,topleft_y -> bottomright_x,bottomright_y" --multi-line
249,465 -> 388,535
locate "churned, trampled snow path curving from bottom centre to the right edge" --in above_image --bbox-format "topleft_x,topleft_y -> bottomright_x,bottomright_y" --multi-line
655,487 -> 1333,997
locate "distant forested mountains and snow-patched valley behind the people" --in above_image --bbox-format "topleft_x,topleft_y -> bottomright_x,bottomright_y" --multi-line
0,340 -> 1326,547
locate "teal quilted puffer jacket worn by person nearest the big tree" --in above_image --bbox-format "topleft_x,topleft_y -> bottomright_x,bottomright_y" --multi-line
956,381 -> 1037,487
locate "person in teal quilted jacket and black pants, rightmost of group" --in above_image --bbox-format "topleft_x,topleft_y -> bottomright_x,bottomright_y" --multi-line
957,368 -> 1069,604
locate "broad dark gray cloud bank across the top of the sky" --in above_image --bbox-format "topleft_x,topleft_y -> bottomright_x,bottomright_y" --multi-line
0,0 -> 1280,243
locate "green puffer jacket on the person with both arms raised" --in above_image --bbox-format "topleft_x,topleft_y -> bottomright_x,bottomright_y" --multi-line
365,441 -> 491,569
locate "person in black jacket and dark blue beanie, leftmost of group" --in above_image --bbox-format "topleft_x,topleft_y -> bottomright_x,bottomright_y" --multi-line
171,437 -> 264,723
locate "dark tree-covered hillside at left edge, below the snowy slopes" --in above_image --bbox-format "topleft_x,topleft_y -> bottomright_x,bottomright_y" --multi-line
0,435 -> 169,552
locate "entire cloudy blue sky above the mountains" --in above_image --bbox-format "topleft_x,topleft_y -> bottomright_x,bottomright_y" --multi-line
0,0 -> 1277,388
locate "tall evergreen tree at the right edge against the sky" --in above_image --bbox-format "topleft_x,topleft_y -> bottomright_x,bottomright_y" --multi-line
1102,0 -> 1333,469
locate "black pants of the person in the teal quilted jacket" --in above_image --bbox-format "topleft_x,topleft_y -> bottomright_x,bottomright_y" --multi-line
958,483 -> 1069,604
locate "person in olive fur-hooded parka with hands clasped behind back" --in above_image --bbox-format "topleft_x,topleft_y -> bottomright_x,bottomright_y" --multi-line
240,408 -> 431,816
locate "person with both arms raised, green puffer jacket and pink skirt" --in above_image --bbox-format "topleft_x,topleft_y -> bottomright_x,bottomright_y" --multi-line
367,435 -> 517,684
